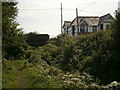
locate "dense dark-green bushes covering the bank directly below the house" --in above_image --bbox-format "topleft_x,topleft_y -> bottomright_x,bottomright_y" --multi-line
30,31 -> 115,84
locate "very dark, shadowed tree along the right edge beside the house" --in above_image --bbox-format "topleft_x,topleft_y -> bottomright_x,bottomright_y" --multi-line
112,12 -> 120,81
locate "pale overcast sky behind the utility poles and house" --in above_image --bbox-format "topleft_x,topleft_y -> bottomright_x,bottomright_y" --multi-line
17,0 -> 120,38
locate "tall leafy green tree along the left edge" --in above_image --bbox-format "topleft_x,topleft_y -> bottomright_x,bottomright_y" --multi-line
2,2 -> 27,59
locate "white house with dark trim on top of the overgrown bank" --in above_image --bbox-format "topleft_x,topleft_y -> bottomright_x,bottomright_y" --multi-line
63,14 -> 113,36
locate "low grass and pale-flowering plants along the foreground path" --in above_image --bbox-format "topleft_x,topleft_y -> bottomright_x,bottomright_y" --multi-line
3,60 -> 93,88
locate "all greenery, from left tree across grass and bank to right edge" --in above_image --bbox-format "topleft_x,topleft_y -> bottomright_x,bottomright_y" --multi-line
2,2 -> 120,88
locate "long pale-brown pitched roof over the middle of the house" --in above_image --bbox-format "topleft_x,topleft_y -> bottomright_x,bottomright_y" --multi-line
70,16 -> 99,26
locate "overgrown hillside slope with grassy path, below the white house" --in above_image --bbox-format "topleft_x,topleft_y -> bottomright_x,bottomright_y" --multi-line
3,31 -> 120,88
